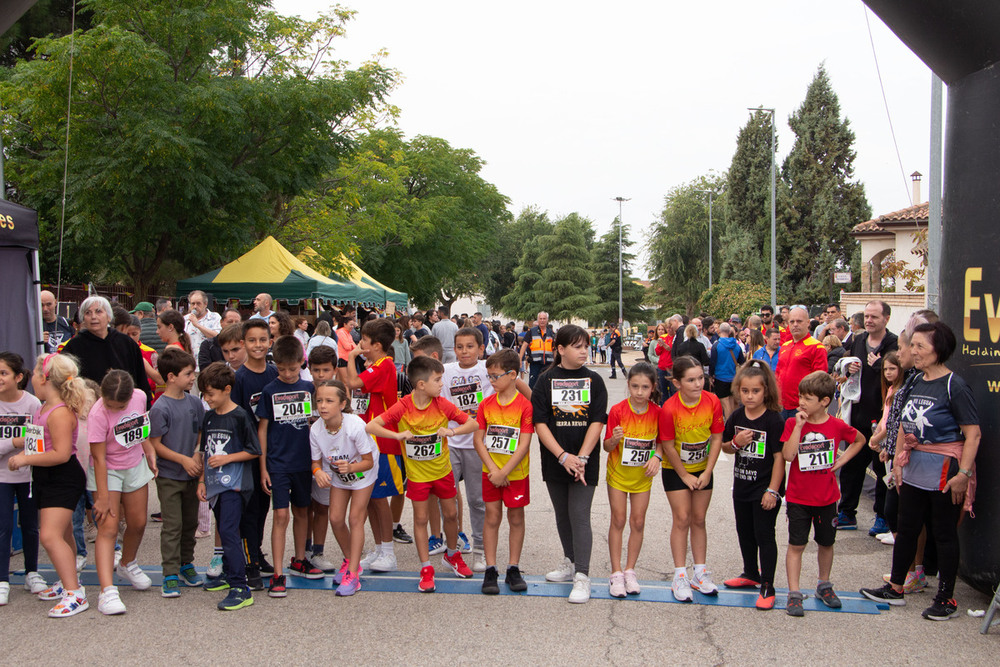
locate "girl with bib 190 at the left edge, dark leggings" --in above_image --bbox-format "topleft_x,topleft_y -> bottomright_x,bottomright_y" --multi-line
0,352 -> 46,606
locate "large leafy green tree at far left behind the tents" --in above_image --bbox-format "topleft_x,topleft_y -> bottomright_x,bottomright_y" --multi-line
0,0 -> 397,294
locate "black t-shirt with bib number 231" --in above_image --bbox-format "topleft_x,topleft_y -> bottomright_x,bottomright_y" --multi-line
531,366 -> 608,486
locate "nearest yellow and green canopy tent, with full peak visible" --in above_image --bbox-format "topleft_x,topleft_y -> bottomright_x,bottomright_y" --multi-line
177,236 -> 386,306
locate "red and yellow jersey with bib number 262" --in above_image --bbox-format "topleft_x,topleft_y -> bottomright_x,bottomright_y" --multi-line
380,394 -> 469,482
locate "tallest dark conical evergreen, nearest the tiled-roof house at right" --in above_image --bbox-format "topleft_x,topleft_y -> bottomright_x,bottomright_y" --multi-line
778,65 -> 871,303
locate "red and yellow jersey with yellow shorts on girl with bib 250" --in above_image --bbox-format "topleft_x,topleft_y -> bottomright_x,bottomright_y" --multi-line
604,398 -> 660,493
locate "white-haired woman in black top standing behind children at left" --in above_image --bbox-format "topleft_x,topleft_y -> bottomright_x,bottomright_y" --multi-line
63,296 -> 152,407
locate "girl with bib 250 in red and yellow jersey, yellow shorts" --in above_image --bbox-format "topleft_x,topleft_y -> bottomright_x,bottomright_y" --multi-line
604,361 -> 663,598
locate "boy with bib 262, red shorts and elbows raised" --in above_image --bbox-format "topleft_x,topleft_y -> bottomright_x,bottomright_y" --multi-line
366,357 -> 476,593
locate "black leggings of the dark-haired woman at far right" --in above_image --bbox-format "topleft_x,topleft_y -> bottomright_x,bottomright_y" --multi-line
890,482 -> 962,600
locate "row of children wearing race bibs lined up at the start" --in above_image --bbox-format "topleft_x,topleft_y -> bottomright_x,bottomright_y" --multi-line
0,319 -> 892,617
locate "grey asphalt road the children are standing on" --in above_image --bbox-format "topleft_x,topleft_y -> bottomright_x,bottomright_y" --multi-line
0,353 -> 1000,665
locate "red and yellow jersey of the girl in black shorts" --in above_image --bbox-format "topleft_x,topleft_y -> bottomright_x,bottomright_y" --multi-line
660,391 -> 725,472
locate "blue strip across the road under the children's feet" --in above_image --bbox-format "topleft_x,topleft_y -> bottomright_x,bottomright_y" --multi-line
11,566 -> 889,614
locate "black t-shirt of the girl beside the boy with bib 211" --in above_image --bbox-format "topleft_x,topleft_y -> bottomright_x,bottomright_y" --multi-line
722,405 -> 785,502
